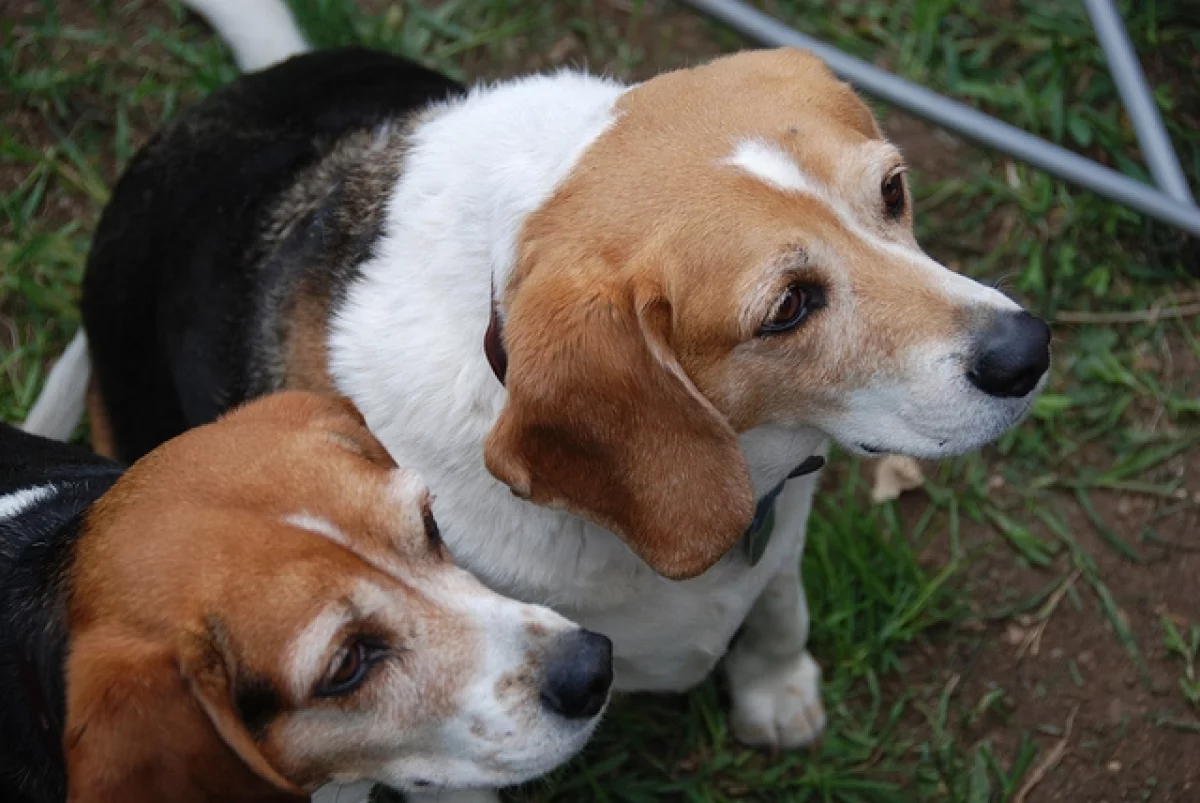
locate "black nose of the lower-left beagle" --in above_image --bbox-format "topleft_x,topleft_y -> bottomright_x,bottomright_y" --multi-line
541,629 -> 612,719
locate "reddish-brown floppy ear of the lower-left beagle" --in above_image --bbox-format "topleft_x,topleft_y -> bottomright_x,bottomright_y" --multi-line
64,633 -> 305,803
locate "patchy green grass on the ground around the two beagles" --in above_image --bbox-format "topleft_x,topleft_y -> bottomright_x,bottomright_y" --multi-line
0,0 -> 1200,803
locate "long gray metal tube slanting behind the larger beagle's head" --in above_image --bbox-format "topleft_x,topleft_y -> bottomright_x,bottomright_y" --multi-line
682,0 -> 1200,236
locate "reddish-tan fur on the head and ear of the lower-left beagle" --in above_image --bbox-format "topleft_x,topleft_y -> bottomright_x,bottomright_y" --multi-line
65,392 -> 476,803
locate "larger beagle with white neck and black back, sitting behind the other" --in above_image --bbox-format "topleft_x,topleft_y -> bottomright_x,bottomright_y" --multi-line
30,0 -> 1050,796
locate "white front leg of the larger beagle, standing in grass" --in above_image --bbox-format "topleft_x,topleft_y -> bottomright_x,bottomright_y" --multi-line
725,561 -> 826,748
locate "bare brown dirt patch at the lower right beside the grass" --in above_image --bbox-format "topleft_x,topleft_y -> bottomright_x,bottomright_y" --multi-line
893,453 -> 1200,803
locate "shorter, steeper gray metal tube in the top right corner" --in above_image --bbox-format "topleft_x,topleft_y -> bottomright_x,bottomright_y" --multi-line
1084,0 -> 1195,204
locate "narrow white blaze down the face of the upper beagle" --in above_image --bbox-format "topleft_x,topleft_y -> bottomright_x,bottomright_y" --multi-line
721,138 -> 1020,311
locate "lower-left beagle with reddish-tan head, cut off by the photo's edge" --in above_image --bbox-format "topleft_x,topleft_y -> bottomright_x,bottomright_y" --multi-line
0,392 -> 612,803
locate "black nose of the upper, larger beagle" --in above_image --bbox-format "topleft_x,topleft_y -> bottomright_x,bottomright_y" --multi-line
967,312 -> 1050,397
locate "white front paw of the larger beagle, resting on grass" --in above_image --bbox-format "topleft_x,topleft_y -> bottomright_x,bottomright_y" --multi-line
730,652 -> 826,748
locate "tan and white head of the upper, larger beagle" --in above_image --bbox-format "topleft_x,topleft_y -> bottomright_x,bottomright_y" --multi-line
486,49 -> 1049,579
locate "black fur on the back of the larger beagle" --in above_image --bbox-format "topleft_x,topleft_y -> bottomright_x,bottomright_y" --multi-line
83,48 -> 462,461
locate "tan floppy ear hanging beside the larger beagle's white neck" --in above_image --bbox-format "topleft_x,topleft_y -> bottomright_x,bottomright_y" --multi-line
484,274 -> 754,580
